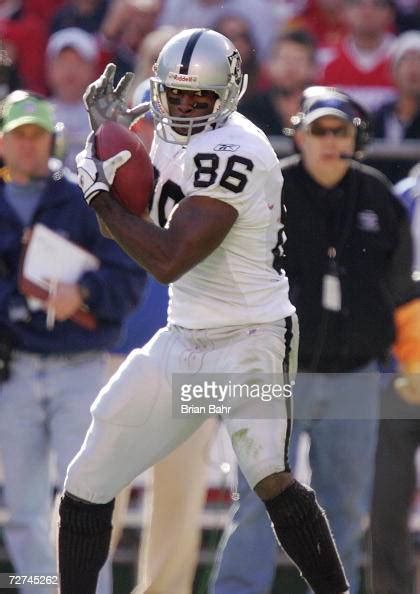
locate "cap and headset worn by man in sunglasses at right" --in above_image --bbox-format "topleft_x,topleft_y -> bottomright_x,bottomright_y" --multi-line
283,86 -> 371,158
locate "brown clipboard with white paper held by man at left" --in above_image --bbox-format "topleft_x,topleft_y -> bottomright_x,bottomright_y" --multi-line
18,223 -> 100,330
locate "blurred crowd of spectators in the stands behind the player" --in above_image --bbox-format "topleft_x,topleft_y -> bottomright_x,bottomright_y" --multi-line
0,0 -> 420,183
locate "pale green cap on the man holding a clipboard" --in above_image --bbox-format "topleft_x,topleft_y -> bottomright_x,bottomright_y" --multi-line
2,91 -> 55,133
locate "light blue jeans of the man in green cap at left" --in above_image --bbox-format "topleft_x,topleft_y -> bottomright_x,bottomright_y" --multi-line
0,352 -> 112,594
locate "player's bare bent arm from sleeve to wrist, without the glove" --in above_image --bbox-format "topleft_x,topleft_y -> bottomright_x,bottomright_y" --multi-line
91,192 -> 238,283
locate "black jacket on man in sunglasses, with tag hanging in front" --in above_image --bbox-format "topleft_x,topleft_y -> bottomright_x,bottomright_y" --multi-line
281,156 -> 413,372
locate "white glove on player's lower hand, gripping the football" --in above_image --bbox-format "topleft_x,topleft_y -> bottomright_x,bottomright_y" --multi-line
76,132 -> 131,204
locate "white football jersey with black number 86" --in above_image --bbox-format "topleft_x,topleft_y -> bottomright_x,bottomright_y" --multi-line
151,108 -> 294,329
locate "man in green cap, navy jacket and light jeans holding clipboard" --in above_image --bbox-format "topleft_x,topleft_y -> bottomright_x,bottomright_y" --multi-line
0,91 -> 145,594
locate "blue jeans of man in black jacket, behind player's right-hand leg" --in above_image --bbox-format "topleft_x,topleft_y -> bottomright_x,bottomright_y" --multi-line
209,363 -> 379,594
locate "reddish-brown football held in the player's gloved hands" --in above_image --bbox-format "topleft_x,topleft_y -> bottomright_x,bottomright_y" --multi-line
95,121 -> 153,216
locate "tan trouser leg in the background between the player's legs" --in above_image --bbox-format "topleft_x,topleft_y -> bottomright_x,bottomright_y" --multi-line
134,419 -> 216,594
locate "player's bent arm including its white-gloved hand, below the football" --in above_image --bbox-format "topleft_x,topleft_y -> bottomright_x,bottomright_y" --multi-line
76,133 -> 238,283
